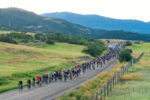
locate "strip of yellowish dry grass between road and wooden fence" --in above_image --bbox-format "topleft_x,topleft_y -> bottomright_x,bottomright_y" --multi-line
58,62 -> 127,100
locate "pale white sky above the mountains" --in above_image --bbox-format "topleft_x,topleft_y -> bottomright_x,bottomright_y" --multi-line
0,0 -> 150,22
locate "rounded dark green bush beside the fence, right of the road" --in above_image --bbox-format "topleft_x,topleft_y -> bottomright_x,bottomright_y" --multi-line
118,49 -> 132,62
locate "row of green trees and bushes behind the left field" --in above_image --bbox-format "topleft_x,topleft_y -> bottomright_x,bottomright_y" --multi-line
0,32 -> 106,57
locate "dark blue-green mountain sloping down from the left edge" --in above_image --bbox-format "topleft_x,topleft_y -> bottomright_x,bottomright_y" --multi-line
0,8 -> 105,35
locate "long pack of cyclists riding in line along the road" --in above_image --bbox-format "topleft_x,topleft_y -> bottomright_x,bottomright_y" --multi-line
18,43 -> 124,89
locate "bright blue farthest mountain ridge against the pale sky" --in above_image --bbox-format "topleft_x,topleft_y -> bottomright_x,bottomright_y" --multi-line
42,12 -> 150,34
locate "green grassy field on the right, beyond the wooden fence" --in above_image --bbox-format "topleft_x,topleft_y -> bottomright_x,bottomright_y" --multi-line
107,43 -> 150,100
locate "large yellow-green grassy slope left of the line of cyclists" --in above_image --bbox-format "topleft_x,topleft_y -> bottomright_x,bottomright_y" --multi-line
0,42 -> 89,92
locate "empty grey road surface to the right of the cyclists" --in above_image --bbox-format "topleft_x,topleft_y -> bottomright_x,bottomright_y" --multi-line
0,58 -> 116,100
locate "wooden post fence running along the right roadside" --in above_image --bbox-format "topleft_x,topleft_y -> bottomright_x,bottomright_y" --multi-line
83,53 -> 144,100
